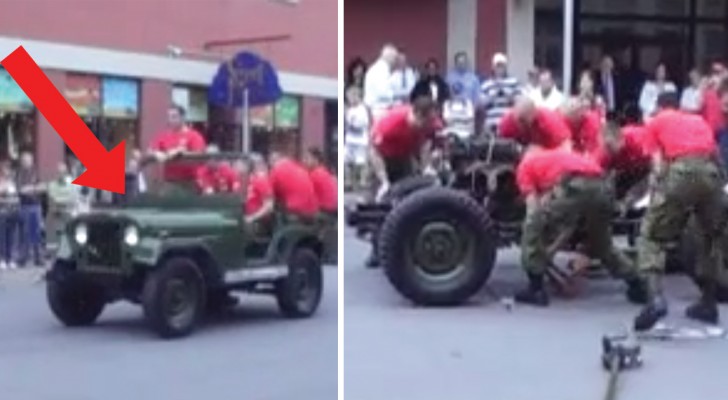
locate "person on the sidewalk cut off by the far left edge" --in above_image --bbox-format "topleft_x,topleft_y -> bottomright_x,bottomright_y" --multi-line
0,161 -> 19,270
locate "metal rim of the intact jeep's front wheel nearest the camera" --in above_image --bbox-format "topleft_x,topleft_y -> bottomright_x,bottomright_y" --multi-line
162,278 -> 199,329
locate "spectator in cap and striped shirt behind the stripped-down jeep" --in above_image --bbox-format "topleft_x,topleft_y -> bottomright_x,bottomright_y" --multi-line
480,53 -> 523,135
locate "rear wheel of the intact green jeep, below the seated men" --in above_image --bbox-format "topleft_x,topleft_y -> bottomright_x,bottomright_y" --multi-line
275,247 -> 323,318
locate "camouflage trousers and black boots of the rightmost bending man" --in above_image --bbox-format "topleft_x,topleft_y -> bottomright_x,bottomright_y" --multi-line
635,157 -> 725,330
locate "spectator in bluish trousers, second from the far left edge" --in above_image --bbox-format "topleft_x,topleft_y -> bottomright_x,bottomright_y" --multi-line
16,152 -> 44,267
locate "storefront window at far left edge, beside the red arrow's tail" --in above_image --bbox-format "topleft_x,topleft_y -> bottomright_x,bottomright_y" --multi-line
0,68 -> 37,160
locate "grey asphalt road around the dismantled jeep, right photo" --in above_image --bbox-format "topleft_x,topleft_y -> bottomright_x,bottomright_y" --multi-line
344,231 -> 728,400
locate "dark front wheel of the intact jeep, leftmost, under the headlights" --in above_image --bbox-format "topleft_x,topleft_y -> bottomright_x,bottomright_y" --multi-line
46,278 -> 106,326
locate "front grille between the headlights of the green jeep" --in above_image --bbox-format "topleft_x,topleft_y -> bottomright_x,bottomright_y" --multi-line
84,221 -> 123,267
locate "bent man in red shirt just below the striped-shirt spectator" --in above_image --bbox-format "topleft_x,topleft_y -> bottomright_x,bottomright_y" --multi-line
499,97 -> 571,149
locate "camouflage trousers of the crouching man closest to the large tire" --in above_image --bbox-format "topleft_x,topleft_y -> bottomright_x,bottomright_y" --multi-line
521,176 -> 637,279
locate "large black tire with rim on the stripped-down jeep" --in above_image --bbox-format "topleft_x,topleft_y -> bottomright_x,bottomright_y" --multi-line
379,188 -> 497,306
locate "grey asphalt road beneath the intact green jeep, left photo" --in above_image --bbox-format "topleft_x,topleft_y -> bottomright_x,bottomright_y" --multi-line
0,267 -> 338,400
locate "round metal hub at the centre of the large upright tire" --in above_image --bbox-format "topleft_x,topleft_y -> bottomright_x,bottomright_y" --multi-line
414,222 -> 466,274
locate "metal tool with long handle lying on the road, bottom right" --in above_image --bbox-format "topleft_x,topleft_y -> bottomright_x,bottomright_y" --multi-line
602,335 -> 642,400
